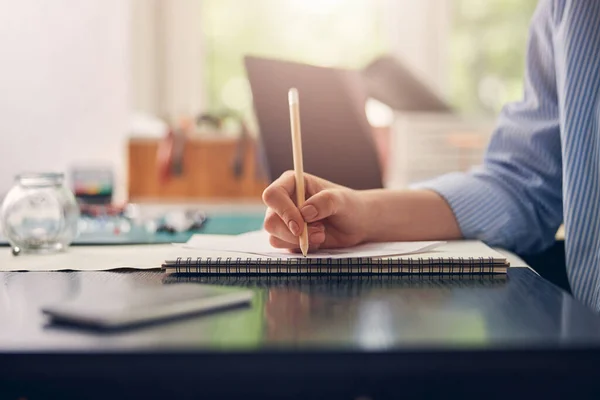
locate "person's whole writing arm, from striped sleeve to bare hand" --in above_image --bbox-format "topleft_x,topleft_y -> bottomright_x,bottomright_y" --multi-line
263,1 -> 562,254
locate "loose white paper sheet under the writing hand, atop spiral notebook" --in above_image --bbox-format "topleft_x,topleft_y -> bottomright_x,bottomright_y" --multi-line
182,231 -> 444,259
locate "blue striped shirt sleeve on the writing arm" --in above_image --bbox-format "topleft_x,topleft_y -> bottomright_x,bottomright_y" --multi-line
415,1 -> 563,254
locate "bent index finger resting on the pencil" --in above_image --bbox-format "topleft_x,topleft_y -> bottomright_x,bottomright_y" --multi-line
262,172 -> 304,237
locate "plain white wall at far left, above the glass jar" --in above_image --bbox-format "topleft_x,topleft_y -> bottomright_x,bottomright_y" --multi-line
0,0 -> 130,197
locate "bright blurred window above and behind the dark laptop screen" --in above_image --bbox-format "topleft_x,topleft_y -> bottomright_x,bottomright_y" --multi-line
202,0 -> 388,115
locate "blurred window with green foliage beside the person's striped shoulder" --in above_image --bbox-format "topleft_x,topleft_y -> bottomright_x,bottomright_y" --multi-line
449,0 -> 537,115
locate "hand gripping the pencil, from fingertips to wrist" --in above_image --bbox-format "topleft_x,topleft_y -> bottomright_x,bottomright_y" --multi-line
263,171 -> 369,251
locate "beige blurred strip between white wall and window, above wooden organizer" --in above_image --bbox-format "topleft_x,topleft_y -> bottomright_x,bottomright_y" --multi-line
130,0 -> 205,121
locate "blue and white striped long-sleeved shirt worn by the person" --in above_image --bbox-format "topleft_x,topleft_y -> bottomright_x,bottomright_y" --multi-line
420,0 -> 600,311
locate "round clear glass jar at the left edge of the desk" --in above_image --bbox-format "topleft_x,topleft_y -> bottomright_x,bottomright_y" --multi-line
1,173 -> 79,253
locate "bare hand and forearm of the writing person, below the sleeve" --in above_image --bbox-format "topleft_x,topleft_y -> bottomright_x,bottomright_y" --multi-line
263,171 -> 460,250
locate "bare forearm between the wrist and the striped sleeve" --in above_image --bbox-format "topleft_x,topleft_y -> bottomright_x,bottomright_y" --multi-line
360,189 -> 462,242
